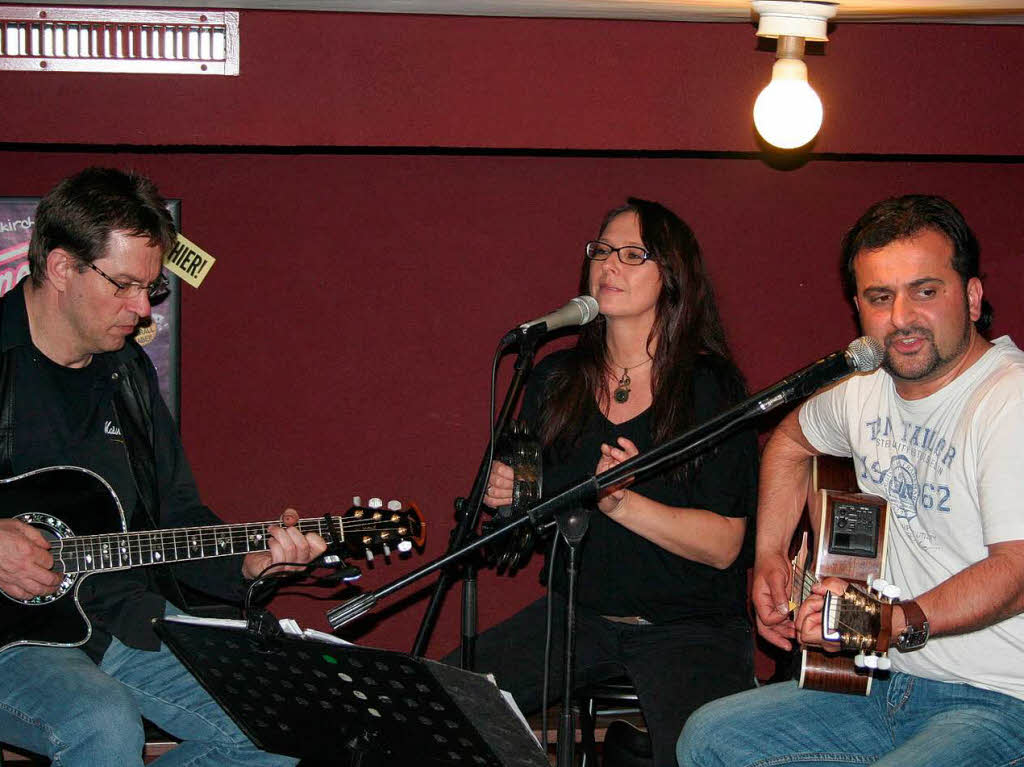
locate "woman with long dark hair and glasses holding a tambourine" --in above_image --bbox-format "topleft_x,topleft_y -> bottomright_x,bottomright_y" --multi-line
462,198 -> 757,767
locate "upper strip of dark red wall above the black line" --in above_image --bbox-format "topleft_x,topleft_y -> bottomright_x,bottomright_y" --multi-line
0,11 -> 1024,155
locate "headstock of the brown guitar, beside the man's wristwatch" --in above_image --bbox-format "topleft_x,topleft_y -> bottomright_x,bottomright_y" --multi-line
821,578 -> 900,671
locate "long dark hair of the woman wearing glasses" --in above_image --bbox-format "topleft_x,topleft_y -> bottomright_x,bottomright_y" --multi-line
540,198 -> 745,466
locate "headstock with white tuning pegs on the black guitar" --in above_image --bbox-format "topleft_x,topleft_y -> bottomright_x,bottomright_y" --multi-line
341,497 -> 426,561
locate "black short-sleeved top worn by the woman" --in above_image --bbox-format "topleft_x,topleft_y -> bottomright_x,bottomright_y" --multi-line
522,350 -> 758,624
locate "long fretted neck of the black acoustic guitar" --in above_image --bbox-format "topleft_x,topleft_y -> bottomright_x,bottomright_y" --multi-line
50,517 -> 344,573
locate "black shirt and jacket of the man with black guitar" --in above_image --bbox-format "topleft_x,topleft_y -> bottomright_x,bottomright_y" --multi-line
0,285 -> 243,662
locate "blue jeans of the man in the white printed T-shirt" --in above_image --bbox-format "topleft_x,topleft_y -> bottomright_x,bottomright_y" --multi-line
676,673 -> 1024,767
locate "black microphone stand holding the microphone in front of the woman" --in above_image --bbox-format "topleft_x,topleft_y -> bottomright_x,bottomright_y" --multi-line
412,335 -> 545,671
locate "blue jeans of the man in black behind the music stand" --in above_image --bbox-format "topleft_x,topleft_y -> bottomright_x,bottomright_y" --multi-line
0,610 -> 298,767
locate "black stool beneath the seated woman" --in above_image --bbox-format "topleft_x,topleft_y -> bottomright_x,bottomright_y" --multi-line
577,677 -> 654,767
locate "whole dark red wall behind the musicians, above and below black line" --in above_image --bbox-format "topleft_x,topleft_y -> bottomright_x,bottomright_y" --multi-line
0,12 -> 1024,655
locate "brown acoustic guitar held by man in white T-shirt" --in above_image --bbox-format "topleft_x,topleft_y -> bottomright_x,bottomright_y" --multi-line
790,456 -> 899,695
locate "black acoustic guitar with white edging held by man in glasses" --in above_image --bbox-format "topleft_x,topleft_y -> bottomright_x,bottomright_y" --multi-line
0,466 -> 424,651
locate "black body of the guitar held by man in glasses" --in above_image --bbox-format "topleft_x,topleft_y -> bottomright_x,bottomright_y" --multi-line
0,466 -> 125,652
